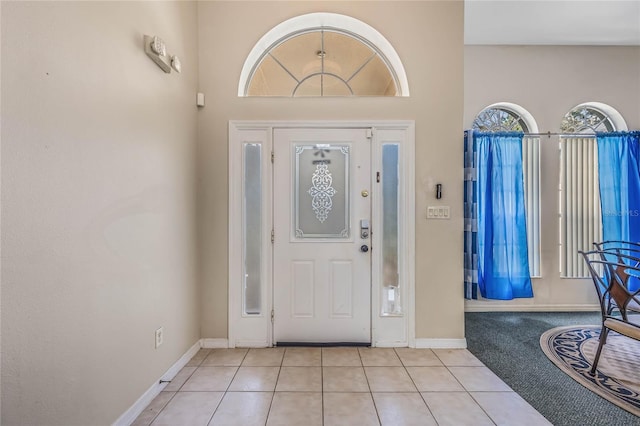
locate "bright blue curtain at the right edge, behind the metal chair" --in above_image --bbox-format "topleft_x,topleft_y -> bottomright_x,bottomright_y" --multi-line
596,132 -> 640,291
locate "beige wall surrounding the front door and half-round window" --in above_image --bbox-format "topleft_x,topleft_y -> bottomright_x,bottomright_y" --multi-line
198,1 -> 464,338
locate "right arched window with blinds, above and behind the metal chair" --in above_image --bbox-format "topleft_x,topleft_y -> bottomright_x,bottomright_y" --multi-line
559,102 -> 627,278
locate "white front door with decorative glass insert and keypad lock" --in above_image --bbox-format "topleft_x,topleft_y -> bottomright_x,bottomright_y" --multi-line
273,128 -> 372,344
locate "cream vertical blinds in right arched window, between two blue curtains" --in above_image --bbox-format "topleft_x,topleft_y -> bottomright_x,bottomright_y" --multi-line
559,136 -> 602,278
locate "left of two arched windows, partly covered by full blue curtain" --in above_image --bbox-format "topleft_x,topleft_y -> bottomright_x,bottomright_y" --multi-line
472,102 -> 541,277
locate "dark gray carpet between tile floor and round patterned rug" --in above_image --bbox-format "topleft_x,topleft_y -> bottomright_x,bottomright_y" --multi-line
465,312 -> 640,426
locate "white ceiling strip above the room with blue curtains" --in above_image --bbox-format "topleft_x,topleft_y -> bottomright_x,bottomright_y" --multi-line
464,0 -> 640,46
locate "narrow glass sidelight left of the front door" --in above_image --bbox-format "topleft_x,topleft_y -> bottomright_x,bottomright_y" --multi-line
242,143 -> 262,315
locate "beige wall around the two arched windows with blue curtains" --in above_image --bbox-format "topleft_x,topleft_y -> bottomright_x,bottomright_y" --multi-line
464,46 -> 640,310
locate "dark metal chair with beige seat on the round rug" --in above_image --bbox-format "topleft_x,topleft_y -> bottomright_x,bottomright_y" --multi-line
580,251 -> 640,375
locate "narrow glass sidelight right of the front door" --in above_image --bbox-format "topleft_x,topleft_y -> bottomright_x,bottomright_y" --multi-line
381,143 -> 403,316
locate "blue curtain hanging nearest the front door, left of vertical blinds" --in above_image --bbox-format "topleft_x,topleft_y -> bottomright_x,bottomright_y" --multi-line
472,132 -> 533,300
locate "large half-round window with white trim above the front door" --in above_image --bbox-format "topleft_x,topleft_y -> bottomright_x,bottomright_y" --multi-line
238,13 -> 409,97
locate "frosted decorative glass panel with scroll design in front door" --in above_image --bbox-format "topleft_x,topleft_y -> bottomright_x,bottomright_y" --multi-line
293,144 -> 350,239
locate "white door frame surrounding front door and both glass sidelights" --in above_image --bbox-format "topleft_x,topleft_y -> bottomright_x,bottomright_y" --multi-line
227,120 -> 415,348
